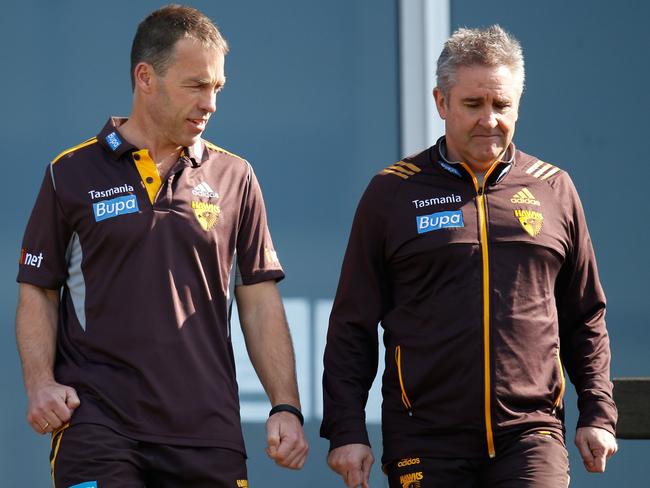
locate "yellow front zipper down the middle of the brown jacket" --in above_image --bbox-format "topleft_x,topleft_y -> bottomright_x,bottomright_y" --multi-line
460,163 -> 497,458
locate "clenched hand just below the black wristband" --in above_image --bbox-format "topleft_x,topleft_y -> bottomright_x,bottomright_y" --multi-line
266,412 -> 309,469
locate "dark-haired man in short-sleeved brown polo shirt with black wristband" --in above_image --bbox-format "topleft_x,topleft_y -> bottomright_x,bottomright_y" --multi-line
16,6 -> 307,488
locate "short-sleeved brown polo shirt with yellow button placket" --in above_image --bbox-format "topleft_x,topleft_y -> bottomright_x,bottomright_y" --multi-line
18,119 -> 284,452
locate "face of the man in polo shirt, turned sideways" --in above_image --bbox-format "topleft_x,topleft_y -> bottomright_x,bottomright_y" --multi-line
147,38 -> 226,147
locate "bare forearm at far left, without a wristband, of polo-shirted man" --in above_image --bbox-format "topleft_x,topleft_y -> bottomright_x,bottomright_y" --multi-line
16,283 -> 59,391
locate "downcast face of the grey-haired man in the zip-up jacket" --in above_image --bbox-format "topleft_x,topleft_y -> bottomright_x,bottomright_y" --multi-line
434,65 -> 521,171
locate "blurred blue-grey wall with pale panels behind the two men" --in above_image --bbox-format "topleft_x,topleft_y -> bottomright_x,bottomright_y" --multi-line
0,0 -> 650,488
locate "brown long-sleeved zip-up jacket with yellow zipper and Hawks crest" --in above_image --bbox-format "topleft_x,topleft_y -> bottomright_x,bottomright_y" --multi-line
321,140 -> 617,463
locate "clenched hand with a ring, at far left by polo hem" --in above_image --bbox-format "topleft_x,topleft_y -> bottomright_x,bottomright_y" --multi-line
27,381 -> 80,434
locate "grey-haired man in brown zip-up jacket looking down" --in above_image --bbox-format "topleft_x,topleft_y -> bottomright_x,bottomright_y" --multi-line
321,26 -> 617,488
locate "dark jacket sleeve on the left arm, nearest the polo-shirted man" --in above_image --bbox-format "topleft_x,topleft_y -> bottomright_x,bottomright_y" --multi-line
321,180 -> 388,449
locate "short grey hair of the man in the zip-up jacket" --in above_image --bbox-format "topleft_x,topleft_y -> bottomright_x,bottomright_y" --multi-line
436,25 -> 525,95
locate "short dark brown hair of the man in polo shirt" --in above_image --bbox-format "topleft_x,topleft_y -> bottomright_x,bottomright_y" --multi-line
131,5 -> 228,88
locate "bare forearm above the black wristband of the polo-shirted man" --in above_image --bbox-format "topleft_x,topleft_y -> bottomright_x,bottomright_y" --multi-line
236,282 -> 300,408
